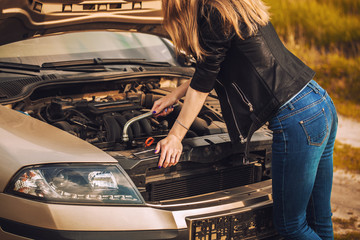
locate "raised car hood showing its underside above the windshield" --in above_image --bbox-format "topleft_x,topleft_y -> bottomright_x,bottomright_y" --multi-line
0,0 -> 167,45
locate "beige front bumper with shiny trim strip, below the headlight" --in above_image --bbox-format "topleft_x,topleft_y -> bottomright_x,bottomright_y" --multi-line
0,180 -> 272,231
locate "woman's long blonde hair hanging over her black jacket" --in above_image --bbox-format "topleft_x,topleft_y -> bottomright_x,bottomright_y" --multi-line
162,0 -> 269,60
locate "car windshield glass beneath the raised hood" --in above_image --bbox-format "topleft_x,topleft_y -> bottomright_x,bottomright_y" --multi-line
0,31 -> 176,65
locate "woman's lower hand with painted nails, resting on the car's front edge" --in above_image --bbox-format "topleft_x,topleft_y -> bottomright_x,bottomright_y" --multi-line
155,134 -> 183,168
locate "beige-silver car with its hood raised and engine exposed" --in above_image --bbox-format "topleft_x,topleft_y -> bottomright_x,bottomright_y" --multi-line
0,0 -> 276,240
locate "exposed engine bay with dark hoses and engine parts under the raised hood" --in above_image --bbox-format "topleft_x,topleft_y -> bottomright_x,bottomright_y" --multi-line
13,79 -> 227,151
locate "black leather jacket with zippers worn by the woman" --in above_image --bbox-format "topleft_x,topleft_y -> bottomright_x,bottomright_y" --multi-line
190,6 -> 315,142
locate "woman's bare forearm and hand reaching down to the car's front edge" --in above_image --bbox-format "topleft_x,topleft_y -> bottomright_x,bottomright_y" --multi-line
155,87 -> 209,168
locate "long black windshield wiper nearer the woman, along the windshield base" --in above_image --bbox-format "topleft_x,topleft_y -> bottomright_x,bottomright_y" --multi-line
41,58 -> 171,69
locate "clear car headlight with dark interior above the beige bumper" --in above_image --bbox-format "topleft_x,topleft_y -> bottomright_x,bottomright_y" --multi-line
6,164 -> 143,204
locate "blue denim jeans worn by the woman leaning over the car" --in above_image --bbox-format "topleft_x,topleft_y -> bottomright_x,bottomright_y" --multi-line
269,80 -> 337,240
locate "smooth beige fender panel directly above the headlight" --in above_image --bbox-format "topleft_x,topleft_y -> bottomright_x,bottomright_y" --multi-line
0,105 -> 117,192
